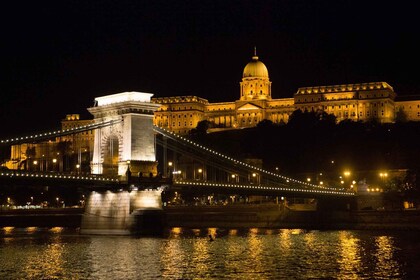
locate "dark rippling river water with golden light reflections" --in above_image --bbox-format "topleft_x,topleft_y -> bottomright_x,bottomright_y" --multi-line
0,228 -> 420,279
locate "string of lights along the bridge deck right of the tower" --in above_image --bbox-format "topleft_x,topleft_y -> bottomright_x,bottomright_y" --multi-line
174,181 -> 354,196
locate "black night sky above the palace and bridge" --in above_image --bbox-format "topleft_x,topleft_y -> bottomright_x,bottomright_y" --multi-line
0,0 -> 420,138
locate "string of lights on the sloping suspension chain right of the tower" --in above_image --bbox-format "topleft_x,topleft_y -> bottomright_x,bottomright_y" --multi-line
154,126 -> 352,192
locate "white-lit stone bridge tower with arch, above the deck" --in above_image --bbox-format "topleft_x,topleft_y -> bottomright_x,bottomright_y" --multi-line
88,92 -> 160,175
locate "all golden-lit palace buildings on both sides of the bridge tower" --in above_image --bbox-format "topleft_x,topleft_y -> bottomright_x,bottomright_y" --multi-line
6,52 -> 420,171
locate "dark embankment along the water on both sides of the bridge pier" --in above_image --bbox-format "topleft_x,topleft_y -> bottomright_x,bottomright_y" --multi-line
0,204 -> 420,230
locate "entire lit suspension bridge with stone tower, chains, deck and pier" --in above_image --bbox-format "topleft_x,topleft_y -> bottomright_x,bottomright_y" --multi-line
0,92 -> 355,233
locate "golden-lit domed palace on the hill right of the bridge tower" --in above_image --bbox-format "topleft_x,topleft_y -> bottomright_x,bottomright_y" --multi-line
152,52 -> 420,134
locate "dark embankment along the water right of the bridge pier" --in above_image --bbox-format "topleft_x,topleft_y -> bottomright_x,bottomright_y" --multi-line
165,205 -> 420,230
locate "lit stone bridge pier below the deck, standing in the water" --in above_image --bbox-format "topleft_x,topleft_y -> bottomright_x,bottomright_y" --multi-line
80,187 -> 164,235
